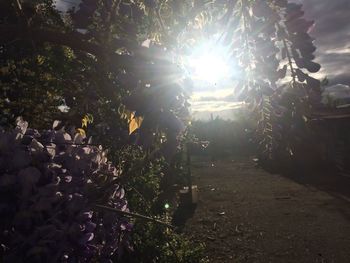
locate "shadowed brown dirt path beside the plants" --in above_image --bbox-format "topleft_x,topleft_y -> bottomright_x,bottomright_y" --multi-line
183,159 -> 350,263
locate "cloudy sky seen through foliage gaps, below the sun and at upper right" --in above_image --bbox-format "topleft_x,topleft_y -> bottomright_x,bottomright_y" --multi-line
56,0 -> 350,116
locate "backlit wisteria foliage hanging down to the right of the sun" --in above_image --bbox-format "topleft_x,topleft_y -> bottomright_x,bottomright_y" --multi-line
183,0 -> 320,164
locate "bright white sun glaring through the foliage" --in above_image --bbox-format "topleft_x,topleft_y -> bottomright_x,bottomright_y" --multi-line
188,42 -> 230,83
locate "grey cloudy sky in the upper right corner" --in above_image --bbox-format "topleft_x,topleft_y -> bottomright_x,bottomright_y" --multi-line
294,0 -> 350,85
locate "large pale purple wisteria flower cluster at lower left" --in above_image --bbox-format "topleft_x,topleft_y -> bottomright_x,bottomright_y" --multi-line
0,118 -> 131,262
